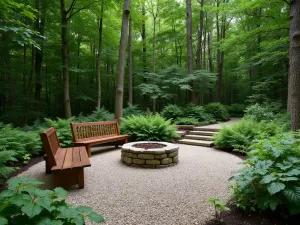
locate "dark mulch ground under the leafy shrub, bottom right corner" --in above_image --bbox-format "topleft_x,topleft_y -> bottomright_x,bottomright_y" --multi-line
206,205 -> 300,225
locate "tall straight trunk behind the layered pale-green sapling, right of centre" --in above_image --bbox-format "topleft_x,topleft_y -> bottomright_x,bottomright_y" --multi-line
186,0 -> 195,103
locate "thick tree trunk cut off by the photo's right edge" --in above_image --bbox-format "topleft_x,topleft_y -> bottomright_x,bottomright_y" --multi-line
289,0 -> 300,131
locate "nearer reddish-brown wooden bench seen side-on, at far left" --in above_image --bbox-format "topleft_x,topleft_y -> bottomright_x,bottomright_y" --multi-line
41,127 -> 91,188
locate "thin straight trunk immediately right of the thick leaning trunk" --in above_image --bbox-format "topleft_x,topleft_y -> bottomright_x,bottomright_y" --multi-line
128,19 -> 133,105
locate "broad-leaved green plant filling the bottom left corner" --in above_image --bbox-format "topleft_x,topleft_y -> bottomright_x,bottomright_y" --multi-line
0,177 -> 104,225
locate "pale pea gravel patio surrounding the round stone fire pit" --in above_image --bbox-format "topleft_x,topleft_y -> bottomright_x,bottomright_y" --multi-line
20,145 -> 241,225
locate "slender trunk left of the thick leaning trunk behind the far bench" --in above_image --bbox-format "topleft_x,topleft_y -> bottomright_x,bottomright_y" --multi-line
96,0 -> 103,109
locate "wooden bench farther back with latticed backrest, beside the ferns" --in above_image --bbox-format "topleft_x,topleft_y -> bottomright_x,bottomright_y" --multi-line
71,120 -> 128,157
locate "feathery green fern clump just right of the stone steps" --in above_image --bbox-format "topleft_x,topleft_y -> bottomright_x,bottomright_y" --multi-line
214,119 -> 282,153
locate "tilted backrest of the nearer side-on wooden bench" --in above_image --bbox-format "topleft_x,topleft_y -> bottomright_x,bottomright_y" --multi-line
40,127 -> 61,167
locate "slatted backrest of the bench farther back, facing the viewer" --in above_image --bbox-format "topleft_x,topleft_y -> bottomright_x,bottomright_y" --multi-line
71,120 -> 120,142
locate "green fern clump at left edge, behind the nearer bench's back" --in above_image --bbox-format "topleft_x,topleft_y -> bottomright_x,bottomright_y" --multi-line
0,124 -> 42,163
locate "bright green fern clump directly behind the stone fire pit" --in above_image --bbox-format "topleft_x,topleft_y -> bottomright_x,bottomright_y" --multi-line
120,114 -> 177,141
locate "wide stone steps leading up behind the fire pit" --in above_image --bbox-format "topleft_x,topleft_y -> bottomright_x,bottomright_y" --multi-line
178,127 -> 220,147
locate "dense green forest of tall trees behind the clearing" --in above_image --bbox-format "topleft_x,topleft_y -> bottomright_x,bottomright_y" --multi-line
0,0 -> 299,126
